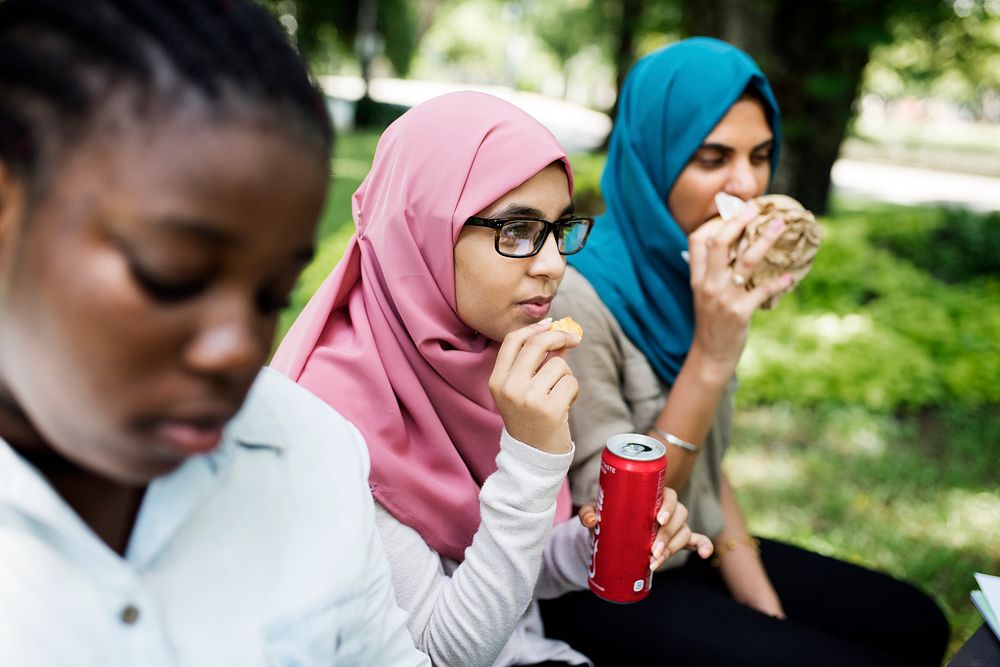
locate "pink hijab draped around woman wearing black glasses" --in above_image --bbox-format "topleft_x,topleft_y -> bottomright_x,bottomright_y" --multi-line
272,92 -> 572,561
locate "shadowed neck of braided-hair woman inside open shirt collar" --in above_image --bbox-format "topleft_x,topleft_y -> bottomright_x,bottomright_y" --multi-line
0,378 -> 145,554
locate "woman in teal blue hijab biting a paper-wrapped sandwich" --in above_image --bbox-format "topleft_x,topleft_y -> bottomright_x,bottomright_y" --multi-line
543,38 -> 948,665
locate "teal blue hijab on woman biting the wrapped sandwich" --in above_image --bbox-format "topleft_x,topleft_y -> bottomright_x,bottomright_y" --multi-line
569,37 -> 781,384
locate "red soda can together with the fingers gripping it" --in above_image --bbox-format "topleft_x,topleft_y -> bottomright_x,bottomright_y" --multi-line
580,433 -> 712,604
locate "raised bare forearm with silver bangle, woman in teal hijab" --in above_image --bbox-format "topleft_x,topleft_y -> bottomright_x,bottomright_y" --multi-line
649,347 -> 731,492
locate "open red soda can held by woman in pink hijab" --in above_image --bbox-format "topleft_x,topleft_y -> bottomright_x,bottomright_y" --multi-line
588,433 -> 667,604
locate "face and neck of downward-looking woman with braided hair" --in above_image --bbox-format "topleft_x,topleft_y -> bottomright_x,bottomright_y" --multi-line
0,108 -> 327,551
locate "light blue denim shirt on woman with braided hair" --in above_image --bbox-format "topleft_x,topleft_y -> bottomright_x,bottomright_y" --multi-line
0,369 -> 429,667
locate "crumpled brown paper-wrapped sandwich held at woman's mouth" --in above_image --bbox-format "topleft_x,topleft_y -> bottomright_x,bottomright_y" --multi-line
729,195 -> 823,308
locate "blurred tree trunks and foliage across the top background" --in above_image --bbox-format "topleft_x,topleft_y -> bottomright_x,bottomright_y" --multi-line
268,0 -> 1000,213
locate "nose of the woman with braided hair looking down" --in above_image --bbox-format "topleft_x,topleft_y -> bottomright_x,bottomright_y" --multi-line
184,298 -> 272,381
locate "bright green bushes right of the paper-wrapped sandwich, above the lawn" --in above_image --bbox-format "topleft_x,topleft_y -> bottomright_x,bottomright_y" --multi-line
739,201 -> 1000,412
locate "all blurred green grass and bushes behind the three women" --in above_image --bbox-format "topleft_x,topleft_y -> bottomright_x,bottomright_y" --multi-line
282,133 -> 1000,655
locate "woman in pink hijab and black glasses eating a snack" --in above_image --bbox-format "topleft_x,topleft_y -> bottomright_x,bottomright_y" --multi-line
273,92 -> 711,666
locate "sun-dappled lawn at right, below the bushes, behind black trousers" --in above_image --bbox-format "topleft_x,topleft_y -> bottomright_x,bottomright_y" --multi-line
726,404 -> 1000,655
